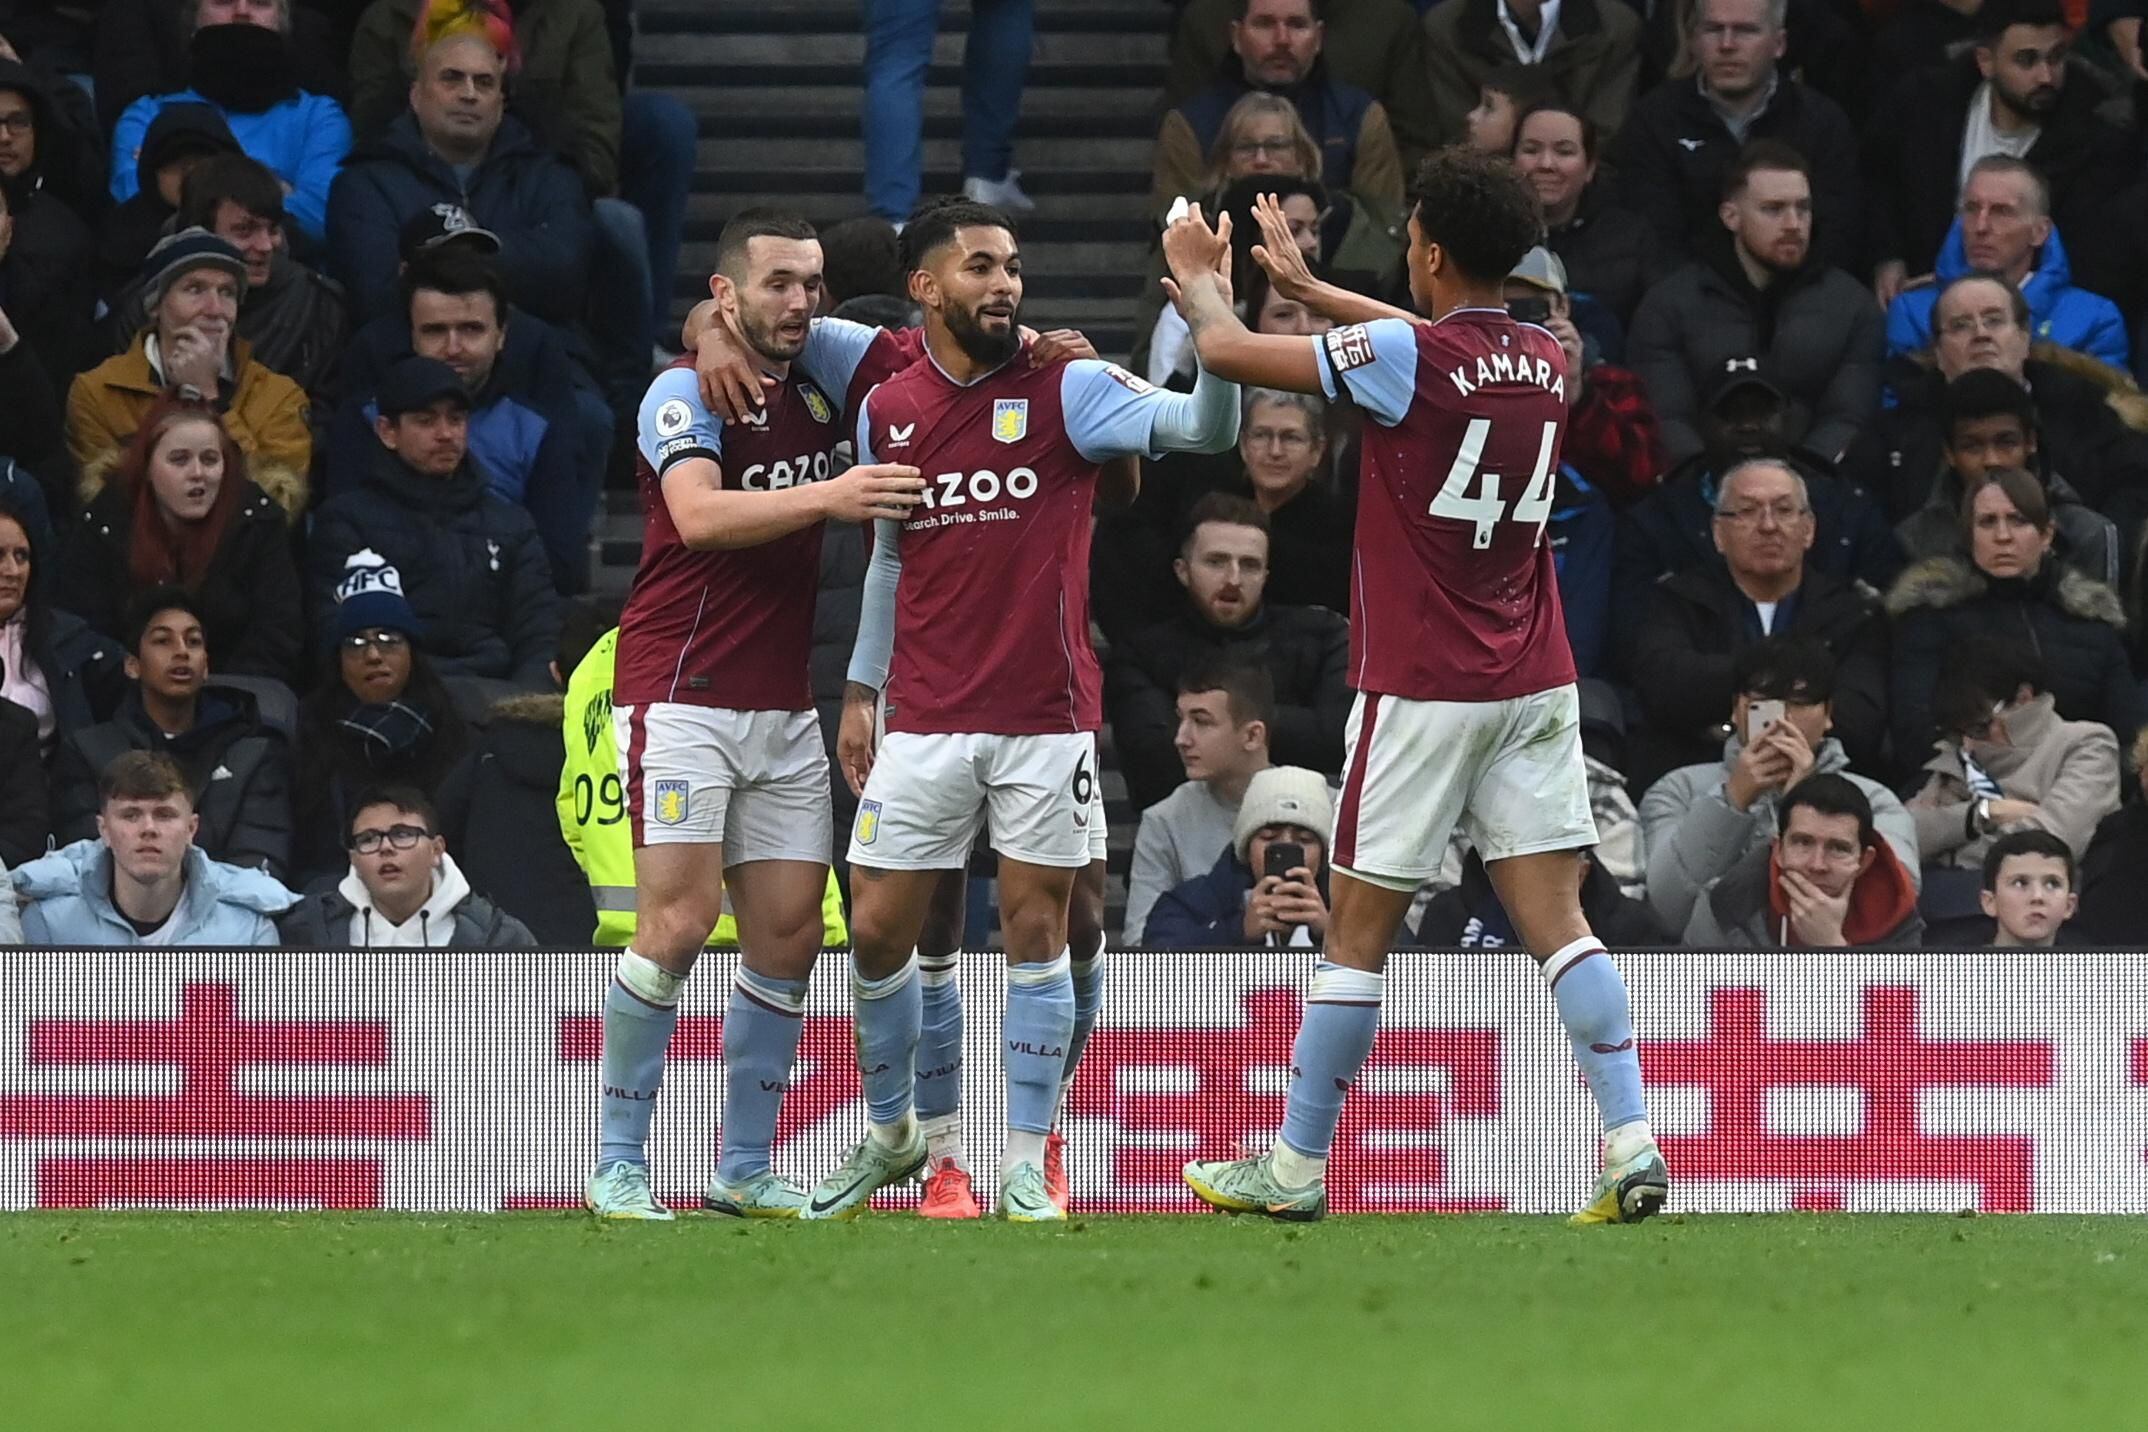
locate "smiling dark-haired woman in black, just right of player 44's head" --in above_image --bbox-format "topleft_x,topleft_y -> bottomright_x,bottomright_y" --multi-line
1512,101 -> 1669,328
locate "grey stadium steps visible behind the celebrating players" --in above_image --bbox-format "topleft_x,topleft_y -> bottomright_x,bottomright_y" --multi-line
597,0 -> 1173,938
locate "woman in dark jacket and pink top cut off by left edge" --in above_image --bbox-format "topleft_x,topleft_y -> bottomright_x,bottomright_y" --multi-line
0,498 -> 127,760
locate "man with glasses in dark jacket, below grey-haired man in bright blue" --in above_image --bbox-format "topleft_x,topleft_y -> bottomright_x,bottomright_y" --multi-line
1843,273 -> 2148,532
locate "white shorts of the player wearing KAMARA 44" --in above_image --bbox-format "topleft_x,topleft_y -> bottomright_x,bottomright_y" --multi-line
1332,685 -> 1596,891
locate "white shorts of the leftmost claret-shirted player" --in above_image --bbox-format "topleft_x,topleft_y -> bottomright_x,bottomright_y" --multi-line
612,702 -> 836,867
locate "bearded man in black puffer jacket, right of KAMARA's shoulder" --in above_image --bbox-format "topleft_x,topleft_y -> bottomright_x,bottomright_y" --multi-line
1626,140 -> 1886,464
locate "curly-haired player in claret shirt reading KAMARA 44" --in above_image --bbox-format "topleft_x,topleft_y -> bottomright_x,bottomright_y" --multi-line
1164,150 -> 1669,1224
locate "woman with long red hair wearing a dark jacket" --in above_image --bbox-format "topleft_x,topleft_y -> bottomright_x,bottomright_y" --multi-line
60,399 -> 305,681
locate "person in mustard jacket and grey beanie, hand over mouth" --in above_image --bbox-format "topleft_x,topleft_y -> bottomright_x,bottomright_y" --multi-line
67,228 -> 314,520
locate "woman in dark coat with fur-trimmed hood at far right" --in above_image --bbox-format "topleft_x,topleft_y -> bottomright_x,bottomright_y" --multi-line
1886,468 -> 2148,764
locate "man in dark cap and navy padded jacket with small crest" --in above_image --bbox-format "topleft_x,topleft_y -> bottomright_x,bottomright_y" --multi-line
307,359 -> 561,691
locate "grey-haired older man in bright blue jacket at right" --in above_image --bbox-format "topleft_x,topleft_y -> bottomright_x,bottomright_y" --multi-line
1886,155 -> 2133,369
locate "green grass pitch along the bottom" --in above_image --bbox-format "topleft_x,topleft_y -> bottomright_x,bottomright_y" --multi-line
0,1213 -> 2148,1432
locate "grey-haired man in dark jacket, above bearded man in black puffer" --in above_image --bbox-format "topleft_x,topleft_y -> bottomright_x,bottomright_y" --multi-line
1611,0 -> 1862,268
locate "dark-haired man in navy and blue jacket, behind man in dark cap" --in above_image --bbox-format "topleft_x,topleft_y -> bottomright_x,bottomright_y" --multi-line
329,243 -> 604,593
